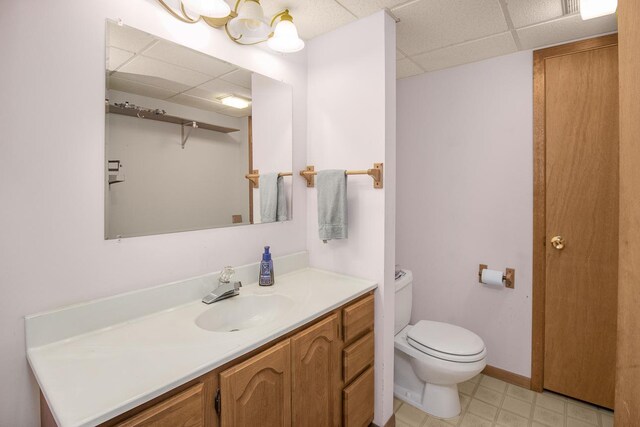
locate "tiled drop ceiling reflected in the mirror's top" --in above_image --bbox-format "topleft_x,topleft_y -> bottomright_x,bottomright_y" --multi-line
107,24 -> 251,117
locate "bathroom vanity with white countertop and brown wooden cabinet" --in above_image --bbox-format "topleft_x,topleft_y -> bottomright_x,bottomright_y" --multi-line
26,258 -> 376,427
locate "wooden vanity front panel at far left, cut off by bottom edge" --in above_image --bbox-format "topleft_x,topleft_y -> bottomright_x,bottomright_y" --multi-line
117,383 -> 204,427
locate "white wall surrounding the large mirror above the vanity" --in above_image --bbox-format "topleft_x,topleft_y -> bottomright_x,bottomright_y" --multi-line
0,0 -> 307,427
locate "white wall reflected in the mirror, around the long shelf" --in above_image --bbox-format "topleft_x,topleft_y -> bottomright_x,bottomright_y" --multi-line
105,90 -> 249,239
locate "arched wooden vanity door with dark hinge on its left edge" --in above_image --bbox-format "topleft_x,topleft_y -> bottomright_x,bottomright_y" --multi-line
220,340 -> 291,427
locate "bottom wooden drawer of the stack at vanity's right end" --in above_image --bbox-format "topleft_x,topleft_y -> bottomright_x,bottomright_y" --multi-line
342,368 -> 373,427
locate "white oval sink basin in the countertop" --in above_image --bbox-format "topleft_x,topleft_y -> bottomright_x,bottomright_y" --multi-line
196,295 -> 293,332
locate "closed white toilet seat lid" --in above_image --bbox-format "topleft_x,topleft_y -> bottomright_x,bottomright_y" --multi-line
407,320 -> 486,362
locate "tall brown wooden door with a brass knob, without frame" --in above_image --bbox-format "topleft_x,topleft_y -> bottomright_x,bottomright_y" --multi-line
543,35 -> 619,408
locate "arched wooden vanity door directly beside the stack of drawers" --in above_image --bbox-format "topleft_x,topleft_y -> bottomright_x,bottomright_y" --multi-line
291,313 -> 340,427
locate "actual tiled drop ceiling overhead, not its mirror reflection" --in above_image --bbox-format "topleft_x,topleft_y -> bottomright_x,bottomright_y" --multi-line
249,0 -> 617,79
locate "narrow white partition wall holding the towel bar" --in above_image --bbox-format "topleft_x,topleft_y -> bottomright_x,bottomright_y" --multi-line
307,12 -> 395,425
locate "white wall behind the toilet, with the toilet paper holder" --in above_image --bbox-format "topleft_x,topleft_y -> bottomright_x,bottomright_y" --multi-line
396,51 -> 533,376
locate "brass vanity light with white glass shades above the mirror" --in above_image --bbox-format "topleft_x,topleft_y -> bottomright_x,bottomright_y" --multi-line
157,0 -> 304,53
